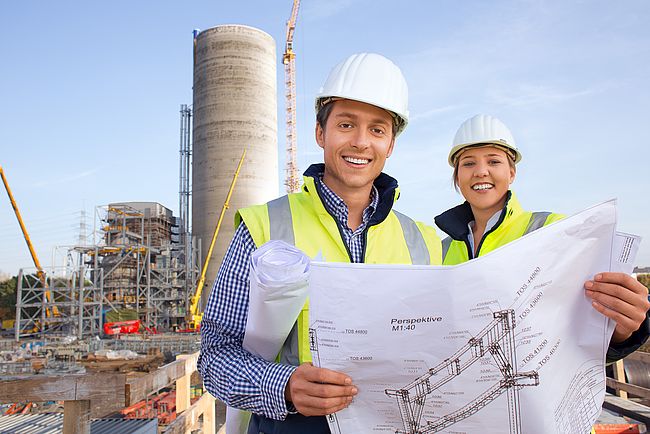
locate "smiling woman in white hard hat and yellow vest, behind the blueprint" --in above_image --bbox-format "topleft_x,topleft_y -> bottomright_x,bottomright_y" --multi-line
435,114 -> 650,360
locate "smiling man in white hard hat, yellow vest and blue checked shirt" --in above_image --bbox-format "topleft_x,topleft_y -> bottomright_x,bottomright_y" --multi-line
199,53 -> 441,434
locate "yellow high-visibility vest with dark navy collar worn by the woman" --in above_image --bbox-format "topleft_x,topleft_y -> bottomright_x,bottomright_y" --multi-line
435,192 -> 564,265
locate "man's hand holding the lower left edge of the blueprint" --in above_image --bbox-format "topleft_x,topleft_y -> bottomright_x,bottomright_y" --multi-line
284,363 -> 357,416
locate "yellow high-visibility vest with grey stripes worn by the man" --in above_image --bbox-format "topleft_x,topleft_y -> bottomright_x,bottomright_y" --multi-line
235,175 -> 441,365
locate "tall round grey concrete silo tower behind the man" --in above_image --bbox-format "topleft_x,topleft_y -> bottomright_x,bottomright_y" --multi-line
192,25 -> 279,306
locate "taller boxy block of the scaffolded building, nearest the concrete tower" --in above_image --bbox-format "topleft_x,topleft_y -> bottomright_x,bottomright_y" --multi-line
94,202 -> 198,330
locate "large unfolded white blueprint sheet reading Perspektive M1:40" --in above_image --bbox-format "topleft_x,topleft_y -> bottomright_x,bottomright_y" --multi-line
310,201 -> 639,434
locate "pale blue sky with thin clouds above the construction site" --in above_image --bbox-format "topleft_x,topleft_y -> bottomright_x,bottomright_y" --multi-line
0,0 -> 650,274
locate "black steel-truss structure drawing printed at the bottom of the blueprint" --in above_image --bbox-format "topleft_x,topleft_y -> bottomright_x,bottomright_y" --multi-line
386,310 -> 539,434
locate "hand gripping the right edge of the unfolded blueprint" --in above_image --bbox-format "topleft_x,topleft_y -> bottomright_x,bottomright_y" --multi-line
585,273 -> 650,343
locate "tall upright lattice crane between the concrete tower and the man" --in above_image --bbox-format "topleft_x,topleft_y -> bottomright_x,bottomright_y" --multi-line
282,0 -> 300,193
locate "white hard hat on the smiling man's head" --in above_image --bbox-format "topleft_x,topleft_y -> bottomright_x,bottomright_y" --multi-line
316,53 -> 409,135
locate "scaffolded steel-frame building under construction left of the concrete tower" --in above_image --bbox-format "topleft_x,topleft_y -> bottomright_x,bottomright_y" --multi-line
16,202 -> 198,339
